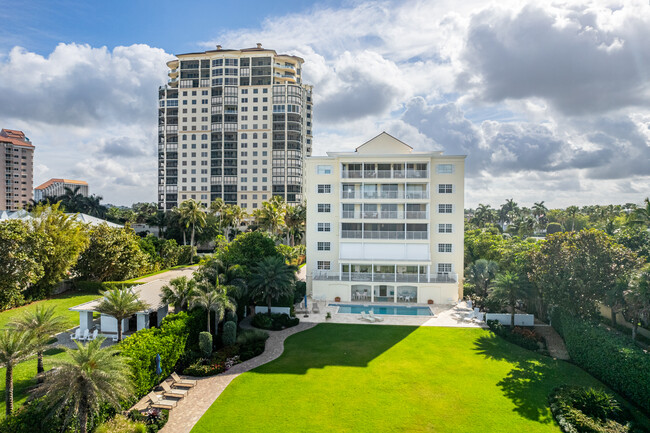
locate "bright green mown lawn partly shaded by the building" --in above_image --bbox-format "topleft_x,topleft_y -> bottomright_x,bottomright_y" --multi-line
192,324 -> 647,433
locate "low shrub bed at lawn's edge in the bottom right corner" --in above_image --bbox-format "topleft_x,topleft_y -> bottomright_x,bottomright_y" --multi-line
548,386 -> 642,433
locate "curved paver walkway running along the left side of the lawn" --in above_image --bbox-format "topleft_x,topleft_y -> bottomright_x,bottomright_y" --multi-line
160,322 -> 316,433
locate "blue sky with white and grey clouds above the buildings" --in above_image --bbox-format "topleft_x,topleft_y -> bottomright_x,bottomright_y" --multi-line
0,0 -> 650,207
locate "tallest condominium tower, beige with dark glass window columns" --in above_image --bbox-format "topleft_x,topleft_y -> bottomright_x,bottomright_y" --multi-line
158,44 -> 312,212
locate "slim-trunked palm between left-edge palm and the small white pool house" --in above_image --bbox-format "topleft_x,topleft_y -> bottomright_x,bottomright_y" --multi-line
9,305 -> 66,382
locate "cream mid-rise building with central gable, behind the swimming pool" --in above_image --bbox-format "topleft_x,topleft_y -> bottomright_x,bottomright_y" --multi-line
305,132 -> 465,304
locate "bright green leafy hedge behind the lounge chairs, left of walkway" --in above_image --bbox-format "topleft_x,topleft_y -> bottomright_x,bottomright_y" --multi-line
120,312 -> 191,398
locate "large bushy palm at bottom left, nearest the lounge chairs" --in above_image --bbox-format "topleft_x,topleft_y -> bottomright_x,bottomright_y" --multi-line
35,337 -> 133,433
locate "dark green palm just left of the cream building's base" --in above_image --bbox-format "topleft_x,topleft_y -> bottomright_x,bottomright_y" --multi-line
248,256 -> 298,314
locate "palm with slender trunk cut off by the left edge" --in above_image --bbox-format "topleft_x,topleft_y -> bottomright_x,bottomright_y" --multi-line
0,329 -> 34,415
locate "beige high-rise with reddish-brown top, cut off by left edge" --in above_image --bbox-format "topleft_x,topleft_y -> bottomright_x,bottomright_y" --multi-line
0,129 -> 34,210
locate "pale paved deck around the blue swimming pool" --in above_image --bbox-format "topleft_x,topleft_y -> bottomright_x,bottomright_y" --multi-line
296,299 -> 487,328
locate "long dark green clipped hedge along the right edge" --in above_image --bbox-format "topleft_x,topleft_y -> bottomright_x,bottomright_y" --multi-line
551,308 -> 650,413
